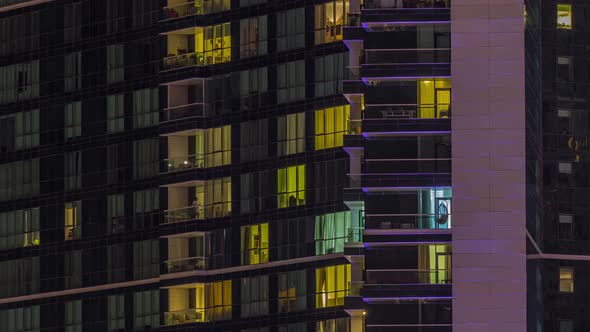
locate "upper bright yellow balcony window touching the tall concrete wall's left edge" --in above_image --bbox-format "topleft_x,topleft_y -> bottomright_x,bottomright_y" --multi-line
416,79 -> 451,119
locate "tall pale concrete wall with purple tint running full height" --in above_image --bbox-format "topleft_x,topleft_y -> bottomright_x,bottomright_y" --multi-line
451,0 -> 526,332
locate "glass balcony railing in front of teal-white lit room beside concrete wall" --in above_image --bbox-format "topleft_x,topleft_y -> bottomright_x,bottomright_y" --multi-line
365,214 -> 451,229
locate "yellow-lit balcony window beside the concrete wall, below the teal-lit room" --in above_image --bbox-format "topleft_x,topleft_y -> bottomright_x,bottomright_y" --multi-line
418,244 -> 452,284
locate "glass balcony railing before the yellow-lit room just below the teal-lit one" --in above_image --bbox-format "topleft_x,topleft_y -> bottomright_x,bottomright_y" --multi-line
365,269 -> 451,285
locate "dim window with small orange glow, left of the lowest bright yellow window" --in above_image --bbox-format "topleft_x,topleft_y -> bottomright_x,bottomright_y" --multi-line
278,270 -> 307,313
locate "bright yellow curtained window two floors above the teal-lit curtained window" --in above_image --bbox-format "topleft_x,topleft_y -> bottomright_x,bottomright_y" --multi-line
315,105 -> 350,150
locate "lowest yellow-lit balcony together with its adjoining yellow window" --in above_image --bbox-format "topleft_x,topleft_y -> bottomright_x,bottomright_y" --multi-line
164,280 -> 232,325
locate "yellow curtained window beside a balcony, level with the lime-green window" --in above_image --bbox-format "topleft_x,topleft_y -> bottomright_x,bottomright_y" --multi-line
204,177 -> 231,218
